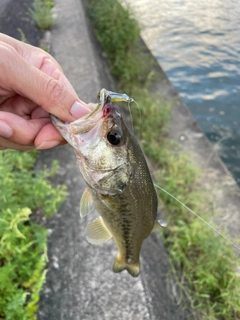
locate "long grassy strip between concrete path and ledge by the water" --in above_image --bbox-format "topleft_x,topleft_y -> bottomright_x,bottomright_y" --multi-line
88,0 -> 240,320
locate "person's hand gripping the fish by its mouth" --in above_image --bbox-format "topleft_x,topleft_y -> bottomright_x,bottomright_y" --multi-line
0,33 -> 89,150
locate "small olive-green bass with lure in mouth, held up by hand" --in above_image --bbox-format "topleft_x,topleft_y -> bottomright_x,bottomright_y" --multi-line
51,89 -> 165,277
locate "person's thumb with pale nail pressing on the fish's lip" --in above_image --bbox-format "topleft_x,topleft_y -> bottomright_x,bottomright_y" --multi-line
0,45 -> 89,121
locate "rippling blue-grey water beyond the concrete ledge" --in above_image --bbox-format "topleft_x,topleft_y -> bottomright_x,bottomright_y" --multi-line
126,0 -> 240,184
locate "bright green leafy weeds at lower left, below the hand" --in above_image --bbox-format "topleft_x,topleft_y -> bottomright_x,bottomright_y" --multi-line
0,150 -> 66,320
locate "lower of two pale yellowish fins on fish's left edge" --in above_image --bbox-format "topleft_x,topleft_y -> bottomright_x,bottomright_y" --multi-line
87,217 -> 112,244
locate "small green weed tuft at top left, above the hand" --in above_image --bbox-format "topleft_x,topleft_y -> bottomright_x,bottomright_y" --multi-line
29,0 -> 56,30
